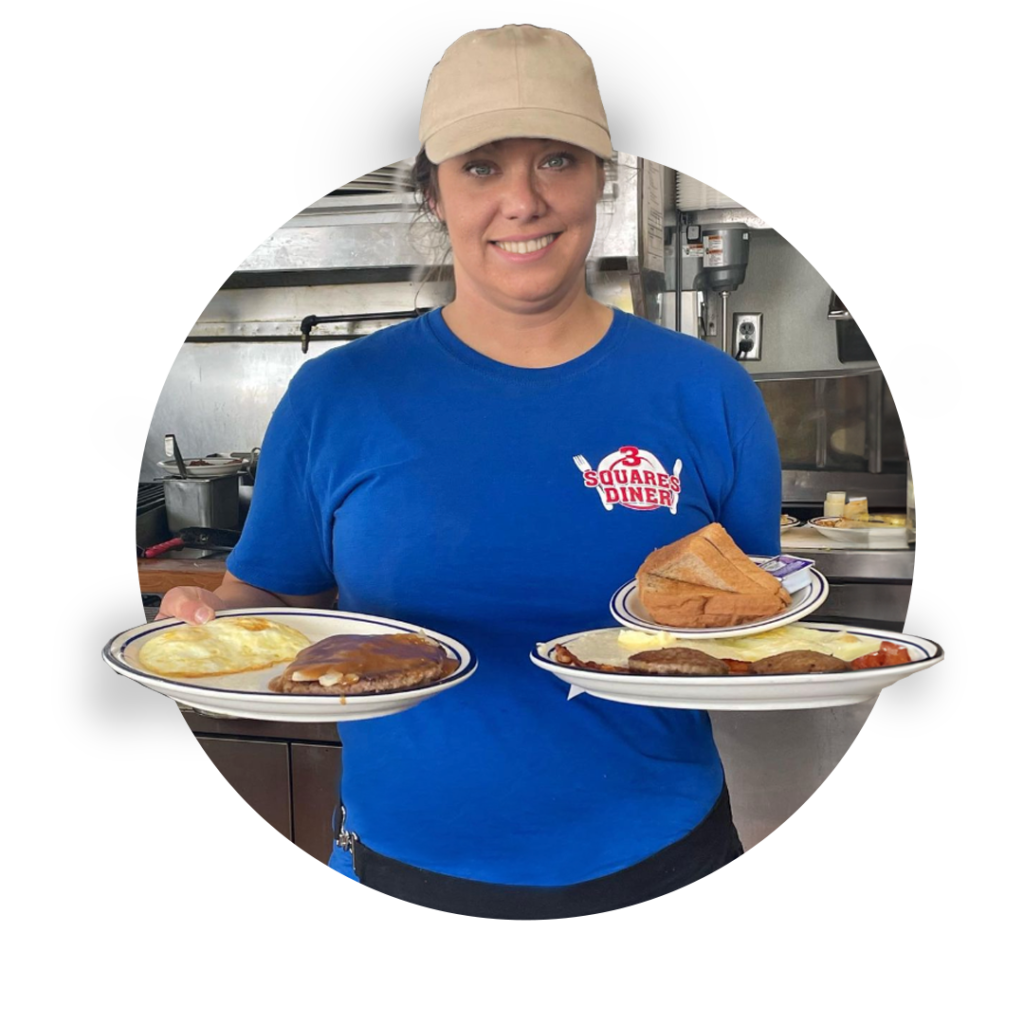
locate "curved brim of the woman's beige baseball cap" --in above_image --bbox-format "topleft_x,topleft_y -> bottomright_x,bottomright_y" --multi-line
424,108 -> 613,164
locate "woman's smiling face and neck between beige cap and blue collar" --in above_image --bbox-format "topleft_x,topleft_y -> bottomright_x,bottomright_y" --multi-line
433,138 -> 611,367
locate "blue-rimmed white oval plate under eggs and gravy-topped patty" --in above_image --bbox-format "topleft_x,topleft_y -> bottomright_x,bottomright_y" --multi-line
103,607 -> 476,722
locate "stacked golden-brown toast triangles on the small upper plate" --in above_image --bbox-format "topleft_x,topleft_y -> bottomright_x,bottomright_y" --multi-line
637,522 -> 793,629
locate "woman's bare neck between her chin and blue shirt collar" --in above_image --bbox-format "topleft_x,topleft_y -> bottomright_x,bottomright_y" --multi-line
441,289 -> 614,369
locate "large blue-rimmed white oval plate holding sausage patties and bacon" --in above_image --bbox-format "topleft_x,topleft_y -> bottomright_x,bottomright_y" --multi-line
529,623 -> 946,711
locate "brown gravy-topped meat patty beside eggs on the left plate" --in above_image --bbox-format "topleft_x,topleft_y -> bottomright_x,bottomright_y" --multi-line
270,633 -> 458,696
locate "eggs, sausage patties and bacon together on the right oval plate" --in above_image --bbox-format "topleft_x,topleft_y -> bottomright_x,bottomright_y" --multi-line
552,626 -> 911,675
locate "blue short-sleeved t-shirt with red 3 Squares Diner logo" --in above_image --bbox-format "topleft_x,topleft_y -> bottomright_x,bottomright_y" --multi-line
227,310 -> 781,886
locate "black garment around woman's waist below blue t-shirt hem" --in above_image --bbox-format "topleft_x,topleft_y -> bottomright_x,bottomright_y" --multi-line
354,786 -> 743,921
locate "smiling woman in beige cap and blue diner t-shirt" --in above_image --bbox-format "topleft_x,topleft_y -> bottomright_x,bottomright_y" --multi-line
162,26 -> 781,921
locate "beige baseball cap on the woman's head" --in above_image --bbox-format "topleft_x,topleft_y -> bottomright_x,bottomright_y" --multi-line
420,25 -> 612,164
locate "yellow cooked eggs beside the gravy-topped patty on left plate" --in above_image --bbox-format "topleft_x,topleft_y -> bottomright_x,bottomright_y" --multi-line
138,615 -> 309,679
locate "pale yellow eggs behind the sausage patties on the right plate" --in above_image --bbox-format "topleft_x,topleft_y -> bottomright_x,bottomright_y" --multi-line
565,626 -> 881,668
